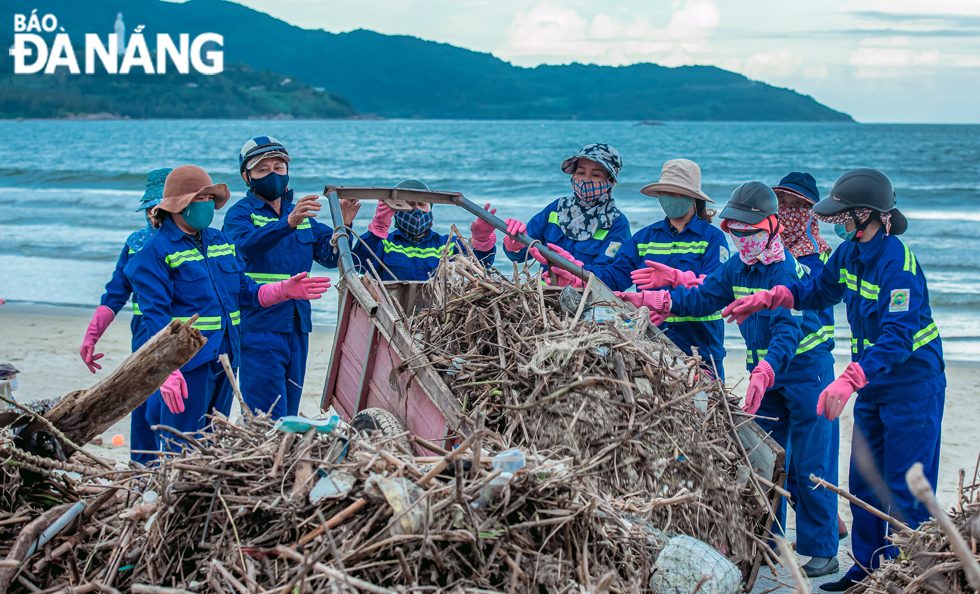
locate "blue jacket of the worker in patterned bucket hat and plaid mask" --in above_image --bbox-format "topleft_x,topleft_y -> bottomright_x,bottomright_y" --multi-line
504,200 -> 630,274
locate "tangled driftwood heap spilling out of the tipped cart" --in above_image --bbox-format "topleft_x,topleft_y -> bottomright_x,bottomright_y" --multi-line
402,255 -> 774,572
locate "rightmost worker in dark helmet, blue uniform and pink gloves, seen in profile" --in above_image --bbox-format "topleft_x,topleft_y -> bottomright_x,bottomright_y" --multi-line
724,169 -> 946,592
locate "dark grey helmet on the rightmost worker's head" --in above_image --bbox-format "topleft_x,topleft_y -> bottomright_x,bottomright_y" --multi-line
813,169 -> 908,235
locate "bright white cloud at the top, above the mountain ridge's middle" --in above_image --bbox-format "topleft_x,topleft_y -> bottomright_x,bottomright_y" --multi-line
494,0 -> 721,66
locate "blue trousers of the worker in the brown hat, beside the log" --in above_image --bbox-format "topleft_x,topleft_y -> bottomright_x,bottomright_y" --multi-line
150,351 -> 234,451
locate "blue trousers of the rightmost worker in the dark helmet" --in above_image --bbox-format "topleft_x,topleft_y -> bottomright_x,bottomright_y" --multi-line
847,386 -> 946,581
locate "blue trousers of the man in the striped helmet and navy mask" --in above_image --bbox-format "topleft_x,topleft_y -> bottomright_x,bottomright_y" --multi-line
238,320 -> 310,420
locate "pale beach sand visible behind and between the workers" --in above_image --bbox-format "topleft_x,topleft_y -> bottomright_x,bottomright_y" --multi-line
0,303 -> 980,591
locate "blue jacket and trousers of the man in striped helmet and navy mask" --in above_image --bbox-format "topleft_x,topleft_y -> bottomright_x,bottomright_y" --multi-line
221,190 -> 337,419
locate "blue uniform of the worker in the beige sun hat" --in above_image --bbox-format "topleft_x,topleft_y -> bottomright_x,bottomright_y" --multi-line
585,218 -> 729,379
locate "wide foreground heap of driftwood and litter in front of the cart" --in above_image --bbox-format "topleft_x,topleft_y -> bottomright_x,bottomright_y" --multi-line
0,408 -> 664,594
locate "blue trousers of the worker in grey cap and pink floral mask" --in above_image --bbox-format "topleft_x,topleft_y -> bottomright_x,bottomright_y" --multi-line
756,366 -> 840,557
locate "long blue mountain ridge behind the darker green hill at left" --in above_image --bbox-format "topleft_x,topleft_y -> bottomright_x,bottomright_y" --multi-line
0,0 -> 853,122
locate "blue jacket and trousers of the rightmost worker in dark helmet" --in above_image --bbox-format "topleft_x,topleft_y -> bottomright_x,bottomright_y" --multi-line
789,231 -> 946,581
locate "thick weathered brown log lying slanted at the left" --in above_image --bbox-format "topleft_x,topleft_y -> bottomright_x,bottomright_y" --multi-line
18,315 -> 207,457
